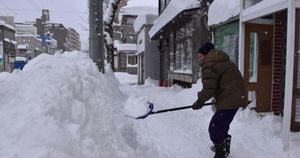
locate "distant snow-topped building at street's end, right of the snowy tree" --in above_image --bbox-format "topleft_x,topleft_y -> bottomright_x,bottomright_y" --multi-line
113,1 -> 157,74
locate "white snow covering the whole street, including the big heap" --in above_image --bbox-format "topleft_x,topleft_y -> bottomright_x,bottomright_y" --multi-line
0,52 -> 300,158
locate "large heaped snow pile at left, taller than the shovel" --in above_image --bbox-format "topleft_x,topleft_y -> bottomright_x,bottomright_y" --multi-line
0,52 -> 133,158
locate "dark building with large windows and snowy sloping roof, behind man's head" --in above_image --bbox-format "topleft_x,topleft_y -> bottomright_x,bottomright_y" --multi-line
149,0 -> 210,87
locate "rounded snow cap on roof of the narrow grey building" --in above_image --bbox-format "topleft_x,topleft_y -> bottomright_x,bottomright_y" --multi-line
133,14 -> 157,32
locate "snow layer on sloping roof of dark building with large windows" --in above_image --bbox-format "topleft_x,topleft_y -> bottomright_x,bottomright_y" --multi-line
149,0 -> 200,38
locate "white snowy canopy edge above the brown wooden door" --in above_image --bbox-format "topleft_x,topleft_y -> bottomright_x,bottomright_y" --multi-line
241,0 -> 288,22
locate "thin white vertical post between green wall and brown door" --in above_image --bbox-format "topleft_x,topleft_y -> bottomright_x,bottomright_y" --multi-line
239,0 -> 245,76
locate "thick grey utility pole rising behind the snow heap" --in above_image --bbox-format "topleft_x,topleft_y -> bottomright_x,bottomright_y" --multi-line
89,0 -> 105,73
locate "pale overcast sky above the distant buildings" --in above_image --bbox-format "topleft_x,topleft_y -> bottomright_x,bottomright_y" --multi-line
0,0 -> 158,48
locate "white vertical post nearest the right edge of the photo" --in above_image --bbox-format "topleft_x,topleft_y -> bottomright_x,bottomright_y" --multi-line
283,0 -> 296,150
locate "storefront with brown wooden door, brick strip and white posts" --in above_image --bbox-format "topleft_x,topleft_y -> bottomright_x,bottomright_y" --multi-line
209,0 -> 300,133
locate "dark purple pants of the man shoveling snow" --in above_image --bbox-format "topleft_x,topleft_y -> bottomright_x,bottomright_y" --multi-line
208,108 -> 238,144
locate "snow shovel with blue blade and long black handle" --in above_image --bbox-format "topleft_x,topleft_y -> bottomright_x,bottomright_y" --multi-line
135,102 -> 214,119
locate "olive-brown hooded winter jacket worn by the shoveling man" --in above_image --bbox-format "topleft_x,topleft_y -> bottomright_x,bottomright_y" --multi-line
198,49 -> 248,110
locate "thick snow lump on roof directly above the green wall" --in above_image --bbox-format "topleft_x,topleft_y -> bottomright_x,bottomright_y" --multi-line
208,0 -> 240,26
